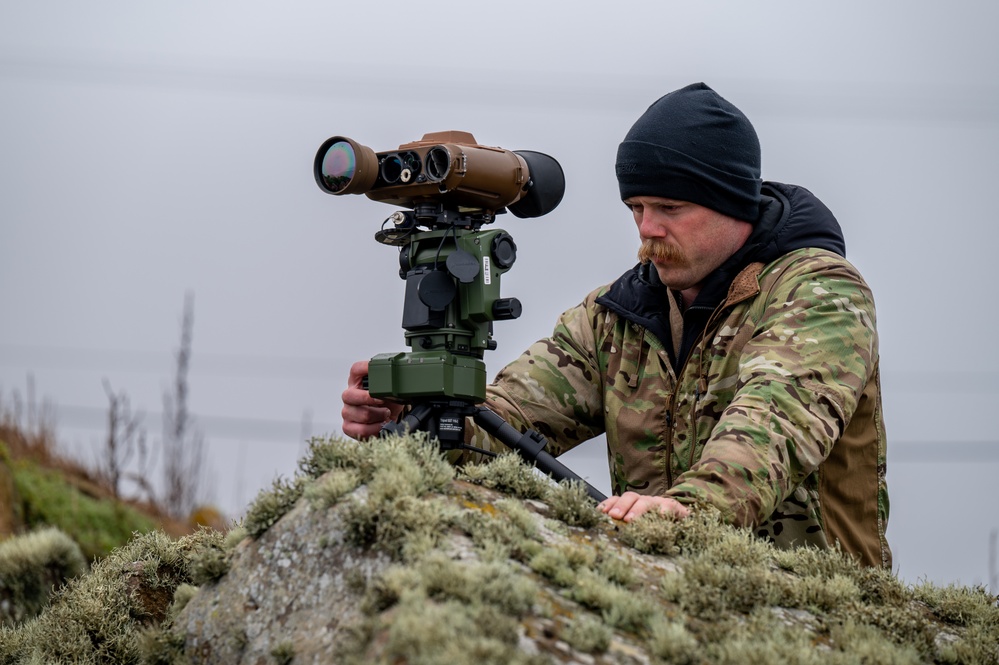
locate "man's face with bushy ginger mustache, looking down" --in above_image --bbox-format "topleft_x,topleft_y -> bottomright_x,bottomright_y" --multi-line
624,196 -> 753,291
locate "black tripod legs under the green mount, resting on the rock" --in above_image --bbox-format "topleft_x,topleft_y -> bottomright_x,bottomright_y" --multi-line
382,400 -> 607,503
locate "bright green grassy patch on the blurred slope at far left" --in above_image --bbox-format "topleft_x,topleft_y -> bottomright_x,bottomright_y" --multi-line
11,460 -> 157,561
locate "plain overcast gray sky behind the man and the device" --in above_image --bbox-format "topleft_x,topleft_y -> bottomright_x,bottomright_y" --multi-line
0,0 -> 999,584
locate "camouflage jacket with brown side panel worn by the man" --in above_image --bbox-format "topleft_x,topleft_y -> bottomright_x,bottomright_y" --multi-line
473,184 -> 891,568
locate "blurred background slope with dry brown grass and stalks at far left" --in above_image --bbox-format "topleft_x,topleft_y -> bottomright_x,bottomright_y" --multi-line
0,368 -> 222,632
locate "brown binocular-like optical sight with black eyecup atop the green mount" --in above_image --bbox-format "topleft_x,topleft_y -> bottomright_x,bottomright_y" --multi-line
315,131 -> 565,217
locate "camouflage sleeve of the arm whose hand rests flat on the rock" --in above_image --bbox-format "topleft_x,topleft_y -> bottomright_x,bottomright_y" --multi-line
667,251 -> 878,525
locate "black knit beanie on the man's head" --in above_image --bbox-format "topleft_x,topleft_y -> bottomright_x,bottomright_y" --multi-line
616,83 -> 762,222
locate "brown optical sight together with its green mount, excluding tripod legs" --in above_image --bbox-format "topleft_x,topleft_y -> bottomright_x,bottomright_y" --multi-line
314,131 -> 565,403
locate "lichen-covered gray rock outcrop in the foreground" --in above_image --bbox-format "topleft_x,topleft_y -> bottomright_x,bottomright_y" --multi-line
0,437 -> 999,665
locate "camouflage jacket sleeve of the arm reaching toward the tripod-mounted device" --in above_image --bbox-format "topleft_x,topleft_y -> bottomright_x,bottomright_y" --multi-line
470,292 -> 604,456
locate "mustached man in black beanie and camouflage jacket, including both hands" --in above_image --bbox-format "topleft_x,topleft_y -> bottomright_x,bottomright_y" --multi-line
343,83 -> 891,568
